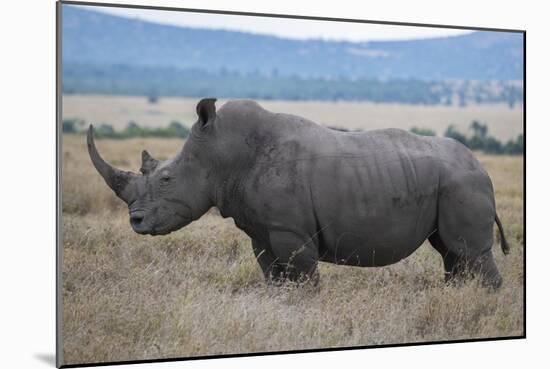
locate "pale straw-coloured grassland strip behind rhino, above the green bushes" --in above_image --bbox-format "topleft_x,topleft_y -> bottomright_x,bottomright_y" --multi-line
63,95 -> 523,142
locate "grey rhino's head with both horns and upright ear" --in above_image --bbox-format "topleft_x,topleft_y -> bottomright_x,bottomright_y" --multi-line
87,99 -> 220,235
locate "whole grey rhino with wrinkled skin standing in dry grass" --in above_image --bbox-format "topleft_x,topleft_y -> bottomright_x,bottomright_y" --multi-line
88,99 -> 508,287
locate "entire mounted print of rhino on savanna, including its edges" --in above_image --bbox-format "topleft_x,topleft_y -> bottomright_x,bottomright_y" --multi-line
57,1 -> 525,366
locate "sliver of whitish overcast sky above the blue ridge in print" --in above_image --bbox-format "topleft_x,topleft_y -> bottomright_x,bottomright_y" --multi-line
84,6 -> 471,41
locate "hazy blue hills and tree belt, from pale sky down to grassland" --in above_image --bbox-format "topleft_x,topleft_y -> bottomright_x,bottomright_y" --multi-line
62,5 -> 523,106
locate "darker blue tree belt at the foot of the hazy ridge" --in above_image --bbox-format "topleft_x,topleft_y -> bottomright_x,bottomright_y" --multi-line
63,64 -> 523,108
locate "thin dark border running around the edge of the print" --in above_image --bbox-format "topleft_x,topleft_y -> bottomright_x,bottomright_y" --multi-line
55,0 -> 527,368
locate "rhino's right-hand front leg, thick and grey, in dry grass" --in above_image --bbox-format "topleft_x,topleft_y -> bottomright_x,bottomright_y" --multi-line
269,231 -> 319,286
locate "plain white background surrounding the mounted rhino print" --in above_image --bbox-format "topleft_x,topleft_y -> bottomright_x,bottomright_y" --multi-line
0,0 -> 550,369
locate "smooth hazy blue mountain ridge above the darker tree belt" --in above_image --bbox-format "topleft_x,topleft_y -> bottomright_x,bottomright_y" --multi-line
62,5 -> 523,81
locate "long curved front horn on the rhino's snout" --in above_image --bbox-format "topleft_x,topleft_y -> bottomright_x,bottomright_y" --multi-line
87,124 -> 135,202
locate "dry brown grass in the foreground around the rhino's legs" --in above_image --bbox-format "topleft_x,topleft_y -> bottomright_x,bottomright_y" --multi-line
62,131 -> 524,364
